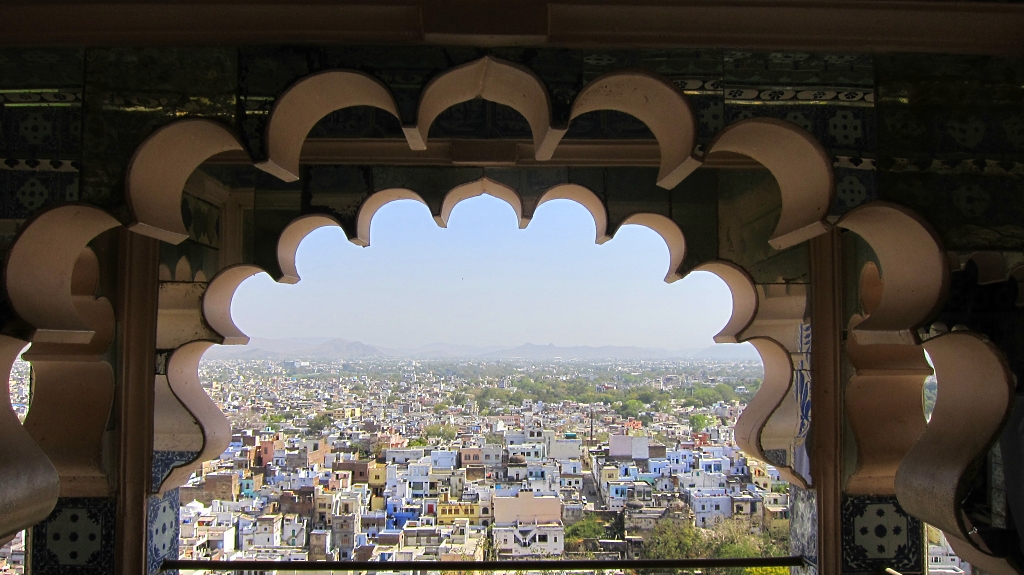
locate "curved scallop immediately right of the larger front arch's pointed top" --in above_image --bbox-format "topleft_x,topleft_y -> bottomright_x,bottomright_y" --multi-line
535,71 -> 699,189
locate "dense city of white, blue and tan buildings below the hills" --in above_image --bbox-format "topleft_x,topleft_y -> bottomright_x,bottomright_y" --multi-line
0,357 -> 958,574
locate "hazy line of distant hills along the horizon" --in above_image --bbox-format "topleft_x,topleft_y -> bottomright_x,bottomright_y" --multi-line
205,338 -> 761,361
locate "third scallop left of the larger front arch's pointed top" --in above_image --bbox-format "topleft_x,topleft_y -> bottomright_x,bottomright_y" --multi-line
4,204 -> 119,344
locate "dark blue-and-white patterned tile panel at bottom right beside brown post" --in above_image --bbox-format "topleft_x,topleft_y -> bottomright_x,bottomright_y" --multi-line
843,495 -> 925,575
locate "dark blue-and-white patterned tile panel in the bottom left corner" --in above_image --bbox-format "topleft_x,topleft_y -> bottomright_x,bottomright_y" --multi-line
32,497 -> 117,575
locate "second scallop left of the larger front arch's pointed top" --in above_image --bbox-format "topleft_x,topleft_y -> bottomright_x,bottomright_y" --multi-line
125,119 -> 243,244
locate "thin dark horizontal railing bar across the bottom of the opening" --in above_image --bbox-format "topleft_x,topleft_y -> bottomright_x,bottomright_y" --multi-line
160,556 -> 808,572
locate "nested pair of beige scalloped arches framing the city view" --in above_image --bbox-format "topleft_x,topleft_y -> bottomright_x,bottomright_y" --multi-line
0,57 -> 1010,572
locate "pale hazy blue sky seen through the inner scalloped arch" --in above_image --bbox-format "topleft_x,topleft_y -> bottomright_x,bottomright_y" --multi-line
232,196 -> 732,350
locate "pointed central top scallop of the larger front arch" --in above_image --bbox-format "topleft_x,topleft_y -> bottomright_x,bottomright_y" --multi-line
403,56 -> 551,149
